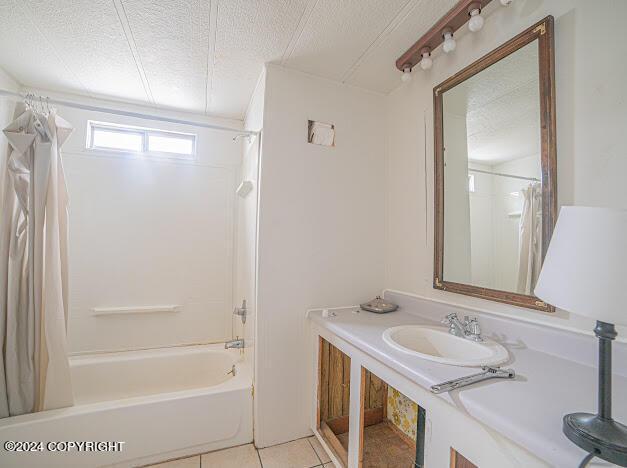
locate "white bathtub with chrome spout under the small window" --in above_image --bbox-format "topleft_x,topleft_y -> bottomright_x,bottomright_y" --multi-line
0,345 -> 253,467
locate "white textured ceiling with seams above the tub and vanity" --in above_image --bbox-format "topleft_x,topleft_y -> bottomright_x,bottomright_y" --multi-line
0,0 -> 455,119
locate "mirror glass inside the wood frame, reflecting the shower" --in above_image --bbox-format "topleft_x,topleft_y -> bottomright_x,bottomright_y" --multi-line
442,40 -> 542,294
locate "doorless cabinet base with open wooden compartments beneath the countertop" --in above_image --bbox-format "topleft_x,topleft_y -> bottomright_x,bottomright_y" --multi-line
311,326 -> 550,468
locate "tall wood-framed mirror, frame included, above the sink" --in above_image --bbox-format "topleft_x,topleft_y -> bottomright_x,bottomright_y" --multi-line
433,16 -> 557,312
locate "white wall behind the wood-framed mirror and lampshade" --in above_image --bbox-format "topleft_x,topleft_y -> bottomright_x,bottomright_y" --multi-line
386,0 -> 627,336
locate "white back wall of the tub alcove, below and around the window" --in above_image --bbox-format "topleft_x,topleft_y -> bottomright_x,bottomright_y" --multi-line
41,93 -> 242,353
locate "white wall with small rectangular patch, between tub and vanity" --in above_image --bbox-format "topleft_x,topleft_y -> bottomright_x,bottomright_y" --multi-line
255,66 -> 385,447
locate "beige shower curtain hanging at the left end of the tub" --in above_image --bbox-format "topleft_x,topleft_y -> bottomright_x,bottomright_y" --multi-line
0,104 -> 73,417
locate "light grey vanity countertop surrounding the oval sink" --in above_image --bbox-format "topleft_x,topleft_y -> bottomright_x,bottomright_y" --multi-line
309,296 -> 627,468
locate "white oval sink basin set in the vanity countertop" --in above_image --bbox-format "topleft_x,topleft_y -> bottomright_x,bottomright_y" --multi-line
383,325 -> 509,367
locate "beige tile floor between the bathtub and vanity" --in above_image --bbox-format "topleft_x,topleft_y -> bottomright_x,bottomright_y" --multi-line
147,436 -> 333,468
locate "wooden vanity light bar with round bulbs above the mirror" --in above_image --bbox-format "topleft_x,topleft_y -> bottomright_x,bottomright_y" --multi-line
396,0 -> 512,77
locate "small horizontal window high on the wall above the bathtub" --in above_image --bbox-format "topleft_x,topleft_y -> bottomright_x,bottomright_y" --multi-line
87,121 -> 196,159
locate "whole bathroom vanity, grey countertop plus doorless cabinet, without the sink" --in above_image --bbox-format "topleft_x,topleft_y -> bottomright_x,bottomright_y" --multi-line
309,292 -> 627,468
